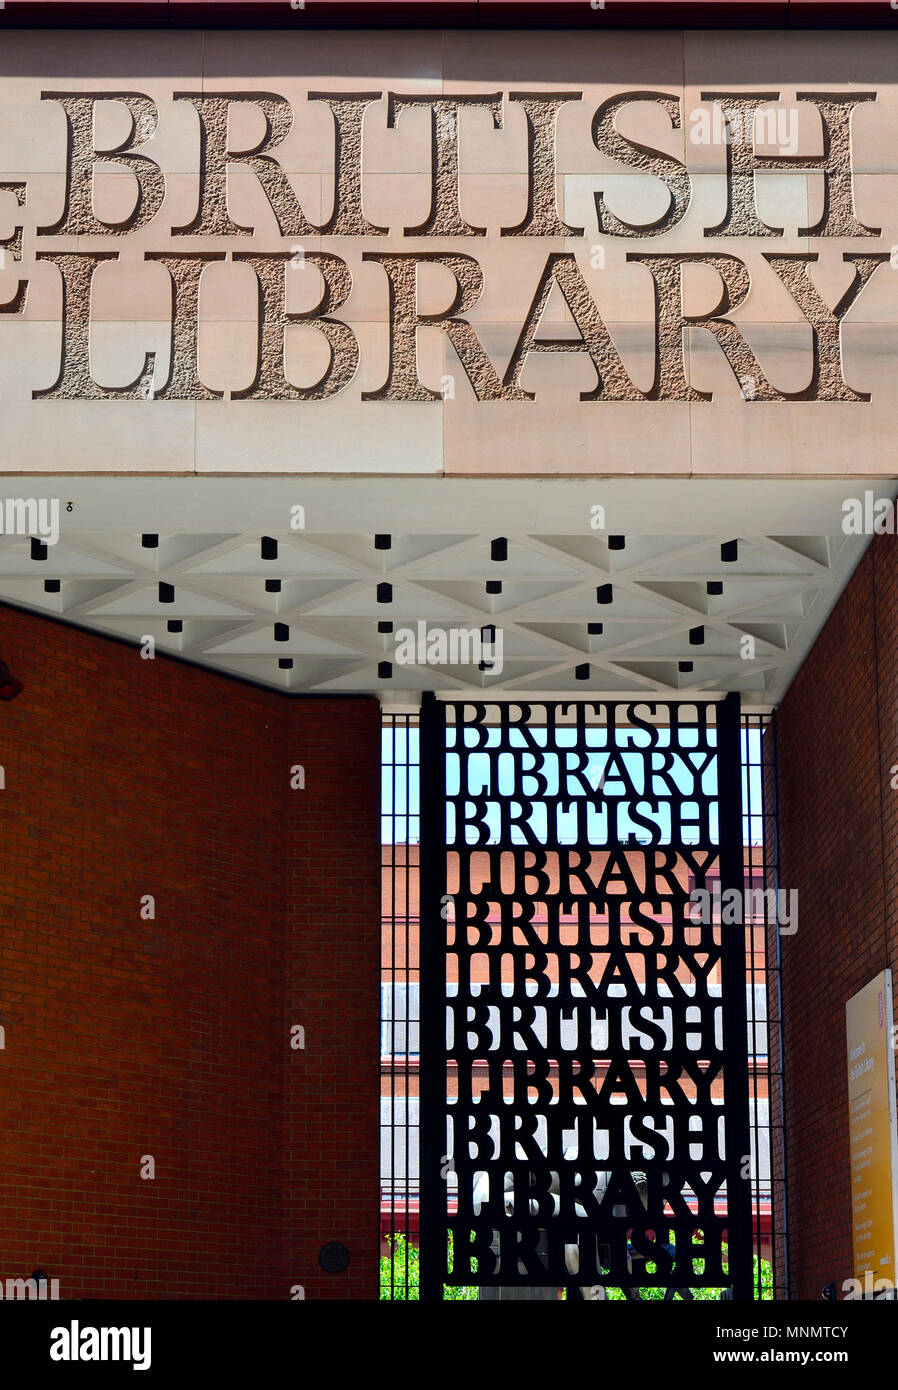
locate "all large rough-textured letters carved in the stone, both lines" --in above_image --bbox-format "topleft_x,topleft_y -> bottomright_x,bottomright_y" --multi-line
0,90 -> 890,402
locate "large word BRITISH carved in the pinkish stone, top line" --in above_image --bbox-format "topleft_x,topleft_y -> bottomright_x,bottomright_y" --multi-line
26,90 -> 879,236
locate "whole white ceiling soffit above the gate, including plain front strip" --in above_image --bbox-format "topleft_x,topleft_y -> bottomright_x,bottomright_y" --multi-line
0,475 -> 898,710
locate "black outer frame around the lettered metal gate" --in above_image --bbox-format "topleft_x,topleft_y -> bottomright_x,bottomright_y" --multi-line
420,694 -> 753,1301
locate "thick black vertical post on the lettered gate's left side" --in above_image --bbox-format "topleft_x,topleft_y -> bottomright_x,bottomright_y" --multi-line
418,691 -> 446,1302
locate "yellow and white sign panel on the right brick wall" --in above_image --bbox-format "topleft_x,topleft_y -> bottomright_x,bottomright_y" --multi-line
845,970 -> 898,1293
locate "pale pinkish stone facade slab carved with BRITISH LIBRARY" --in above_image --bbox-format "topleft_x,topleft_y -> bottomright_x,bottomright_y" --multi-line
0,31 -> 898,477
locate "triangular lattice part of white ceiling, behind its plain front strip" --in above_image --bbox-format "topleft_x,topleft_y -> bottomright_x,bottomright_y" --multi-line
0,480 -> 878,708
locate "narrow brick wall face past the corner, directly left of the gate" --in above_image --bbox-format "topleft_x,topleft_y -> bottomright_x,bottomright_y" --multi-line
284,699 -> 381,1298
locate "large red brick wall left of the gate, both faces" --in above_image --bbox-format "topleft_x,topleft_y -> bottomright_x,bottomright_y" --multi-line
0,609 -> 379,1298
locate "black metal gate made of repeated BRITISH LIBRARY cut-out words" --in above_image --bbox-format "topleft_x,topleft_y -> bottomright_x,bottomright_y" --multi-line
420,695 -> 752,1298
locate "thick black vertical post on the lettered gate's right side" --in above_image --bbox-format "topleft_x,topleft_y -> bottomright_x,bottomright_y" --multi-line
716,694 -> 753,1301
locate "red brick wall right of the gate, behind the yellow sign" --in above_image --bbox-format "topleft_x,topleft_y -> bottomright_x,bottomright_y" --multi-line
776,537 -> 898,1298
